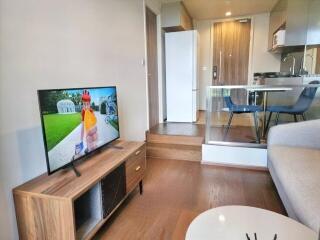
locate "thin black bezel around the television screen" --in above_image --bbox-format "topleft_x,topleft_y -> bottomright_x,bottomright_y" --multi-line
37,86 -> 120,175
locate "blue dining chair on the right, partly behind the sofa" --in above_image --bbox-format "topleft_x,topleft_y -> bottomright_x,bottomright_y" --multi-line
265,81 -> 320,131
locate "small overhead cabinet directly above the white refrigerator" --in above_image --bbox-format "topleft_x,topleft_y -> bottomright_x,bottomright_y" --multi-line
161,2 -> 193,32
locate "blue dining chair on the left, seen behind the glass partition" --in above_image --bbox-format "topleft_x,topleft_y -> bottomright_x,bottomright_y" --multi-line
223,96 -> 262,143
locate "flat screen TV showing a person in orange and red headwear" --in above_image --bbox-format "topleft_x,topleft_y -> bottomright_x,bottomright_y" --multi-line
38,87 -> 120,174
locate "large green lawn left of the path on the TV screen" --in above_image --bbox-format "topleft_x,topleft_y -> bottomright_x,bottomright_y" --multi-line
43,113 -> 81,151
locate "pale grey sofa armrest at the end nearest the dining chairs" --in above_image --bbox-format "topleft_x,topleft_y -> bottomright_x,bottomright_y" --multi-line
268,120 -> 320,149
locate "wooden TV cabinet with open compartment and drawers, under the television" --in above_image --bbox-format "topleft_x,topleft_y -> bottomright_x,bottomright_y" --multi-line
13,140 -> 146,240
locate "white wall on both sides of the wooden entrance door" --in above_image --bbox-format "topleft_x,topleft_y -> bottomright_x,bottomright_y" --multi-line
194,13 -> 280,110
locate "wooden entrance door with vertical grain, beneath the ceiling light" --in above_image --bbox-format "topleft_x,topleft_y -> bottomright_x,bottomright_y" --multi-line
213,19 -> 251,103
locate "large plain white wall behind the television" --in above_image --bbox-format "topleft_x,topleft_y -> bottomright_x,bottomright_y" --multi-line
0,0 -> 147,240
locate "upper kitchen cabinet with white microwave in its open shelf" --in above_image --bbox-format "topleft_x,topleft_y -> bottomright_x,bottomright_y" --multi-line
269,0 -> 312,50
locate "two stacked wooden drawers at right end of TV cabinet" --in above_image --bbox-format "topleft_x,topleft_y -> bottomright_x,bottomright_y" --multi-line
126,146 -> 146,193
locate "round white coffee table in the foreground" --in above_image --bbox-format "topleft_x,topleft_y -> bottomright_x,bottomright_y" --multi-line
186,206 -> 317,240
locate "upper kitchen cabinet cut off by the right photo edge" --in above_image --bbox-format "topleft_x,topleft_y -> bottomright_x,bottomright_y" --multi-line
307,0 -> 320,46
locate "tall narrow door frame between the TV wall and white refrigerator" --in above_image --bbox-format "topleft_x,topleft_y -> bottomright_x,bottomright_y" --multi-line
142,0 -> 165,129
